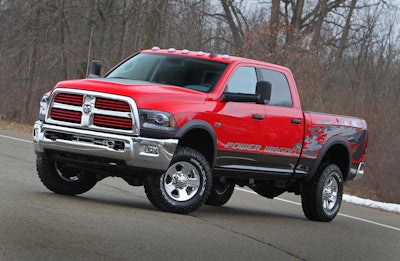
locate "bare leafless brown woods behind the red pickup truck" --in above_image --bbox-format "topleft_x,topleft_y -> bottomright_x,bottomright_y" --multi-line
0,0 -> 400,202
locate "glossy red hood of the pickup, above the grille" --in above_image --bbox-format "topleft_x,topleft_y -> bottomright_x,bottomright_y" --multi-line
56,78 -> 207,109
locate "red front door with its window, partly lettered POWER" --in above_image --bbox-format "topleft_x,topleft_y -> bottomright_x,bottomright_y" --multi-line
214,66 -> 265,170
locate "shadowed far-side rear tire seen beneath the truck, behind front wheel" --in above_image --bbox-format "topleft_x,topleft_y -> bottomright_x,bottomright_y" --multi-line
206,180 -> 235,206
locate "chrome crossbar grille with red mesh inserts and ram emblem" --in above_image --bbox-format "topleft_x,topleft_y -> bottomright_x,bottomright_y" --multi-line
46,88 -> 140,136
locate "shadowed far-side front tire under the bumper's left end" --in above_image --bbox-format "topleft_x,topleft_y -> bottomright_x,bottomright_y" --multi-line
36,157 -> 97,195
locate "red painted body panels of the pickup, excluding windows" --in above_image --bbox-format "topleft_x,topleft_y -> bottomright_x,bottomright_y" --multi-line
48,47 -> 367,179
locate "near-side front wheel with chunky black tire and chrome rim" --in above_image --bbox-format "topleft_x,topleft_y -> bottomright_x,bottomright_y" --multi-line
144,148 -> 212,214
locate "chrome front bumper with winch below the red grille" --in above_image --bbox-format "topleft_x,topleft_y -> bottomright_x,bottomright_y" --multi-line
32,121 -> 178,170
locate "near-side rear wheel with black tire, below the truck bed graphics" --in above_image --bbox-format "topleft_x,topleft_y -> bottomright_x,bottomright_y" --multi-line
301,164 -> 343,222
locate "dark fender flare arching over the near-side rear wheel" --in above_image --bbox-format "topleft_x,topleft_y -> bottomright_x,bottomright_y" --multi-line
310,136 -> 351,178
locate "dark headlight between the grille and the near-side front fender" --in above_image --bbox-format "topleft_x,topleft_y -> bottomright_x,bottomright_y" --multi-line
139,110 -> 176,132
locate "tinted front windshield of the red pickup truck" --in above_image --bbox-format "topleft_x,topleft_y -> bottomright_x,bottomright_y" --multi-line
106,53 -> 227,92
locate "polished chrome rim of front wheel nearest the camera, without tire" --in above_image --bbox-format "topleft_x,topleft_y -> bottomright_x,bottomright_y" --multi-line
162,161 -> 201,202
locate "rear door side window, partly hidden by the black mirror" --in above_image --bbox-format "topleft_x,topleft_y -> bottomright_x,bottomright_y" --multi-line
261,69 -> 292,107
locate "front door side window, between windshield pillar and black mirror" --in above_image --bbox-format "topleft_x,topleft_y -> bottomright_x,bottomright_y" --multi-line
225,67 -> 257,94
